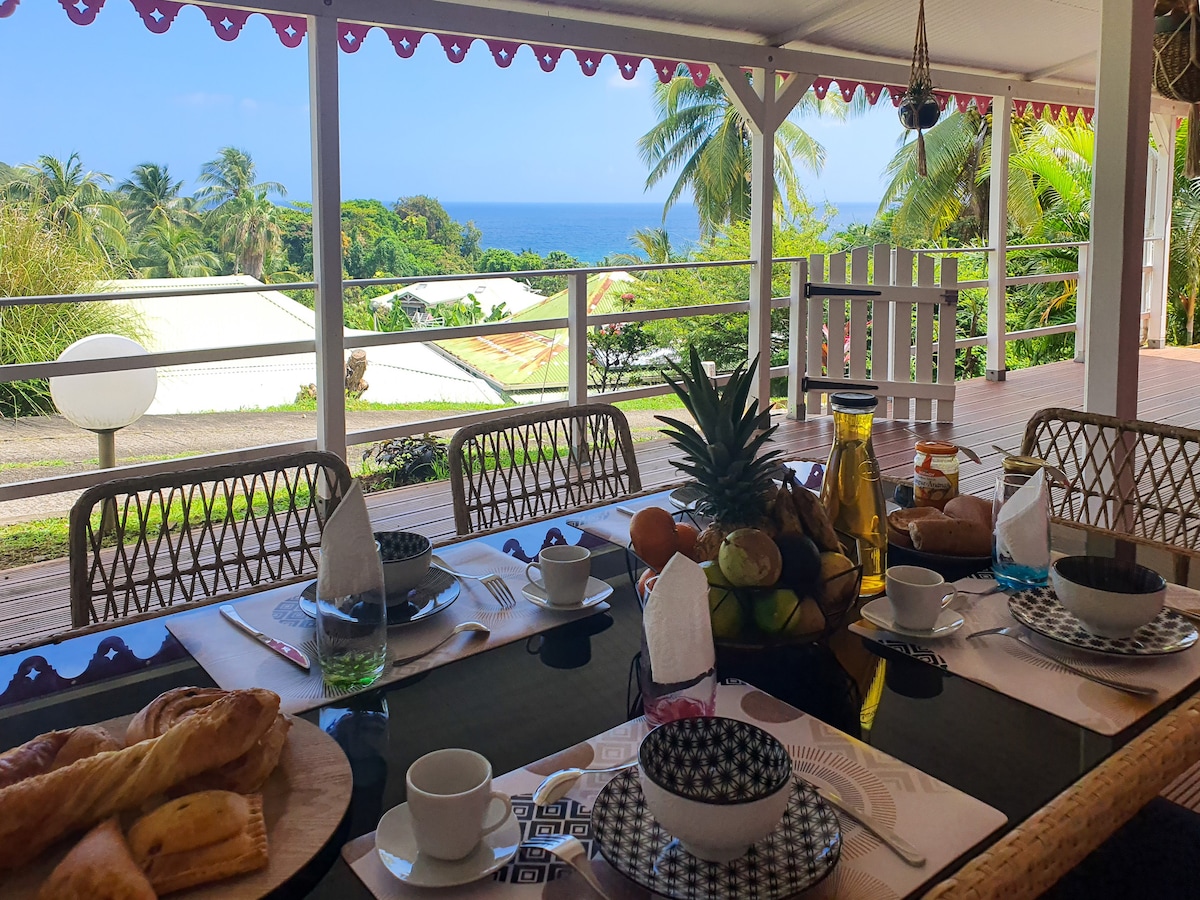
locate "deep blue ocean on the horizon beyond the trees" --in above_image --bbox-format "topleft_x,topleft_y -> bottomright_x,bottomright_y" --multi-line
442,202 -> 877,263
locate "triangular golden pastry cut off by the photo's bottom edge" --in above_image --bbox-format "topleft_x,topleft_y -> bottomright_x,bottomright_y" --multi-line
37,818 -> 157,900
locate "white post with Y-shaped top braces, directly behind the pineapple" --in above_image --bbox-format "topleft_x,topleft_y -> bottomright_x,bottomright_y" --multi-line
716,65 -> 816,408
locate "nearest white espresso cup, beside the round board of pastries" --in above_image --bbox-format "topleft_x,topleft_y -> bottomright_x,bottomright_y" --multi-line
404,748 -> 512,860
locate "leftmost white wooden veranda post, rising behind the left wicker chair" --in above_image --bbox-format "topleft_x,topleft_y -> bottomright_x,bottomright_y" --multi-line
308,11 -> 346,460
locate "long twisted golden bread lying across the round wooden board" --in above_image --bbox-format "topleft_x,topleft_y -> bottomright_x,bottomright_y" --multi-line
0,689 -> 280,871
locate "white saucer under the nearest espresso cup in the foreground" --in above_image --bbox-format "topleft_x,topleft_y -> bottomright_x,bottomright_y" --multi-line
376,799 -> 521,888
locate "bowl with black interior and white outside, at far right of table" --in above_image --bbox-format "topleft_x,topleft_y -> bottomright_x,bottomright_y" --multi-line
1050,557 -> 1166,637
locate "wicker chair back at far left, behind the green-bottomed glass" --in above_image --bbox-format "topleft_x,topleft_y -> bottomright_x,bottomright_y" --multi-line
70,451 -> 350,629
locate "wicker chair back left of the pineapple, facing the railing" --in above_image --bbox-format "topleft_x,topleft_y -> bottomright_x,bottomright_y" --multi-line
450,403 -> 642,534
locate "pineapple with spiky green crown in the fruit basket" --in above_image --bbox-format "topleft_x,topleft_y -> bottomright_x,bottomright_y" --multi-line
655,348 -> 780,559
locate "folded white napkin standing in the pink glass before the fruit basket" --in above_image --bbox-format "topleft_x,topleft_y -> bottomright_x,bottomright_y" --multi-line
642,553 -> 716,684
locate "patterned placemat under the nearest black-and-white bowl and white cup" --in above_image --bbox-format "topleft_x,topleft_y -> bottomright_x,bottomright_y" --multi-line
342,683 -> 1006,900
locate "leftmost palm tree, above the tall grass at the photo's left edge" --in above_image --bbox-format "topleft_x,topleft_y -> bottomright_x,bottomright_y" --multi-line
5,152 -> 127,262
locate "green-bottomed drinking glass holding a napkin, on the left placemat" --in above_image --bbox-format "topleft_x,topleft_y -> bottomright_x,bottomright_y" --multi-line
317,544 -> 388,690
